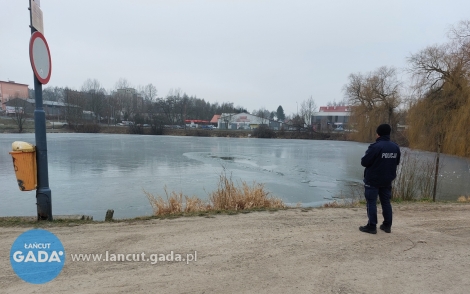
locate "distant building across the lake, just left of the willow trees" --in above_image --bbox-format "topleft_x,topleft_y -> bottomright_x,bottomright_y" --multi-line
312,106 -> 351,131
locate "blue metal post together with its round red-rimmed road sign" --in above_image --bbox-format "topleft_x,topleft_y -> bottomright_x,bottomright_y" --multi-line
29,0 -> 52,221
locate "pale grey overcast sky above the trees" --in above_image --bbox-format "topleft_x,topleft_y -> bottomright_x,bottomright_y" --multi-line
0,0 -> 470,115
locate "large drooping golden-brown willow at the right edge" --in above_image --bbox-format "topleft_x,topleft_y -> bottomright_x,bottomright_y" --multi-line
407,21 -> 470,156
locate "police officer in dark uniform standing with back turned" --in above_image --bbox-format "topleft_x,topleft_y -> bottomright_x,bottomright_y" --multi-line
359,124 -> 401,234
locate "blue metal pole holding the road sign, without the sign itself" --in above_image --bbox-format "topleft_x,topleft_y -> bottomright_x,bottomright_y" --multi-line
29,0 -> 52,221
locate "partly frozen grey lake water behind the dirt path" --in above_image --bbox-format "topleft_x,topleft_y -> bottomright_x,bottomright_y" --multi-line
0,134 -> 470,220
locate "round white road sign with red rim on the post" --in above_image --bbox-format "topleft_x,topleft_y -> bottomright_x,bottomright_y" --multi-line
29,32 -> 52,84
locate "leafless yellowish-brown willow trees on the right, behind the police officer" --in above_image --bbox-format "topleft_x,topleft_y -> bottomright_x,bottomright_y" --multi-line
344,20 -> 470,157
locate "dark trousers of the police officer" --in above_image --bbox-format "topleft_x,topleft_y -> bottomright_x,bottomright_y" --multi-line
364,185 -> 392,227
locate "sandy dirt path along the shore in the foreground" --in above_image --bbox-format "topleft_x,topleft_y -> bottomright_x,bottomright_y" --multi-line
0,204 -> 470,293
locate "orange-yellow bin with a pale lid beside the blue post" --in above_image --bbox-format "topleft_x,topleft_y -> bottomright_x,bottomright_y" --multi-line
10,141 -> 37,191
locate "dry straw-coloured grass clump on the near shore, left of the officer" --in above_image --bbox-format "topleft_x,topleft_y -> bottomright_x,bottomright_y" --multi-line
144,170 -> 286,216
